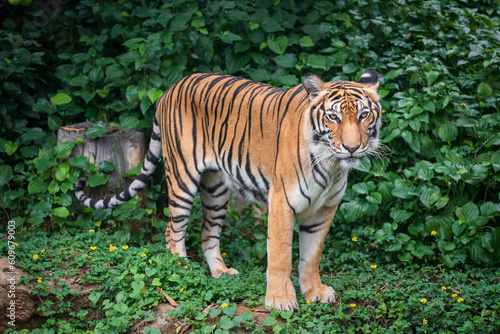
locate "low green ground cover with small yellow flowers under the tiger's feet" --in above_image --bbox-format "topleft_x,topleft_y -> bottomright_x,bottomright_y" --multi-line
2,215 -> 500,333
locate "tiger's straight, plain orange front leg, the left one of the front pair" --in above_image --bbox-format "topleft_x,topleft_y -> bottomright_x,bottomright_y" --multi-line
265,188 -> 298,311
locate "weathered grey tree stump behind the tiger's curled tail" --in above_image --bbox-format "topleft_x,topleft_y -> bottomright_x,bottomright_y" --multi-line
57,122 -> 147,199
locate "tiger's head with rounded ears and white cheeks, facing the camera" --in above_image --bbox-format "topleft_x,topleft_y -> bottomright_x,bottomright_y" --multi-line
304,69 -> 382,169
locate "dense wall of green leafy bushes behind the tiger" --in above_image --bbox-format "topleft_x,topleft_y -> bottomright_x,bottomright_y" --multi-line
0,0 -> 500,331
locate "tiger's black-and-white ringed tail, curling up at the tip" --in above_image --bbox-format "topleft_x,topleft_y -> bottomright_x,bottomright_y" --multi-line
75,117 -> 161,209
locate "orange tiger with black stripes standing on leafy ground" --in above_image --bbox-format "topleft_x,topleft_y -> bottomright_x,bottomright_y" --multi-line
75,69 -> 382,311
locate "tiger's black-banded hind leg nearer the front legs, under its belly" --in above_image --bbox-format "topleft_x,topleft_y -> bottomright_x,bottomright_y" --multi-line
200,171 -> 238,277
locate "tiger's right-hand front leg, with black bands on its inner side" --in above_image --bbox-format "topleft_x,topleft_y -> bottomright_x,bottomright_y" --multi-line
299,205 -> 338,303
